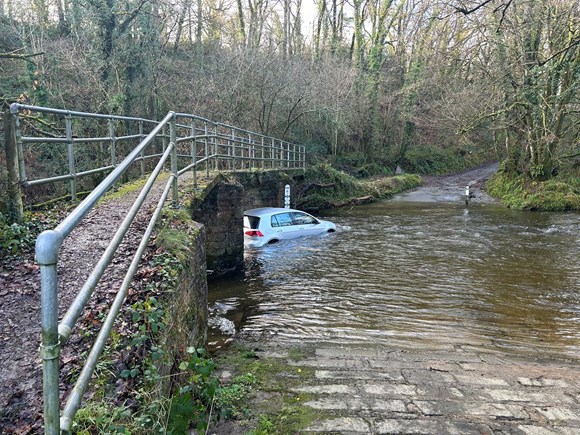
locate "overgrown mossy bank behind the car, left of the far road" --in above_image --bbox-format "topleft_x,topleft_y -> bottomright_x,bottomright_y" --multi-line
297,164 -> 422,209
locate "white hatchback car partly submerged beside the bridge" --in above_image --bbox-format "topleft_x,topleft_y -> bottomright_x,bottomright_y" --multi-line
244,207 -> 336,248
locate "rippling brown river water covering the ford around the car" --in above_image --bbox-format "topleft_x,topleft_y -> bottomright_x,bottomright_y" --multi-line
209,202 -> 580,357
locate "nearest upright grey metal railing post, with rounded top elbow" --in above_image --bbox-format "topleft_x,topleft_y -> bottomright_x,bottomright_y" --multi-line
36,230 -> 63,435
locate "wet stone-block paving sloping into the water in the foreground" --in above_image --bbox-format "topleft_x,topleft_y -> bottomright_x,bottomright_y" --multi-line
253,345 -> 580,435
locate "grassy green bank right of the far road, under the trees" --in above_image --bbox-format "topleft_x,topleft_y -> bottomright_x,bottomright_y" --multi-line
486,169 -> 580,211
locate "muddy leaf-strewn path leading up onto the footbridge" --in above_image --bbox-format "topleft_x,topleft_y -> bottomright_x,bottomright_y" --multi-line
0,176 -> 179,434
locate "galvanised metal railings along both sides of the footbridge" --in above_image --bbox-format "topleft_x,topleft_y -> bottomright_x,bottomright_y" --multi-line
6,104 -> 305,434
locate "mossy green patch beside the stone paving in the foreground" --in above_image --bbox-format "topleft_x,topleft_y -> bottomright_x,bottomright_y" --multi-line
216,343 -> 329,435
